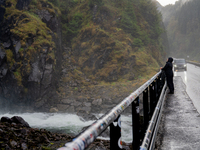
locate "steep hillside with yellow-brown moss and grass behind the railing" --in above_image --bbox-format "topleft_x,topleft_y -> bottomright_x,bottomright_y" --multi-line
59,0 -> 164,97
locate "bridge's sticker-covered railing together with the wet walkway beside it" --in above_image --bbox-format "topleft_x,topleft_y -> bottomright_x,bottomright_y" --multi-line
58,61 -> 200,150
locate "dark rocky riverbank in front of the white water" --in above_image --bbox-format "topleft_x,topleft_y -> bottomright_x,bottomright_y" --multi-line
0,116 -> 131,150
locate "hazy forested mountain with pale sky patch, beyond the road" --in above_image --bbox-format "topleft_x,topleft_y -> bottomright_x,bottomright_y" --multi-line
161,0 -> 200,61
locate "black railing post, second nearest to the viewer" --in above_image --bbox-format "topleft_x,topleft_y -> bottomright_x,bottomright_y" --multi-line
132,97 -> 140,150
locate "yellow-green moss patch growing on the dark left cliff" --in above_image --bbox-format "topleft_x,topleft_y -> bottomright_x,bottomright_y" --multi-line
5,0 -> 59,86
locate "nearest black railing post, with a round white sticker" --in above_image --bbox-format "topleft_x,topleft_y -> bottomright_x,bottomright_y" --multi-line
110,115 -> 122,150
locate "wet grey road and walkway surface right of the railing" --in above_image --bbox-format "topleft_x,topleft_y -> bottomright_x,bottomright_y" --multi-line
155,64 -> 200,150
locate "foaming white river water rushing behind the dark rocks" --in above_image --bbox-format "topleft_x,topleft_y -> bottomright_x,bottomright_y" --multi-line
0,113 -> 132,142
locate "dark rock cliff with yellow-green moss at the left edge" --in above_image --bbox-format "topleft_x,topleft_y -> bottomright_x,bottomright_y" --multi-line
0,0 -> 61,111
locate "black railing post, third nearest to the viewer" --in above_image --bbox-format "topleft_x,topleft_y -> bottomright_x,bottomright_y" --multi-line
143,88 -> 149,130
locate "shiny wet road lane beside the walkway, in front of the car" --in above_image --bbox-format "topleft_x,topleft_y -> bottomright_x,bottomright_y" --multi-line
174,63 -> 200,113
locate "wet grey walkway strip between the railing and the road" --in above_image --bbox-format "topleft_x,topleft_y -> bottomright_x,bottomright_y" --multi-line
157,77 -> 200,150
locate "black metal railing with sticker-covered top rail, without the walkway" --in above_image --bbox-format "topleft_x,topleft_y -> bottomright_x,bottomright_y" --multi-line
58,71 -> 166,150
